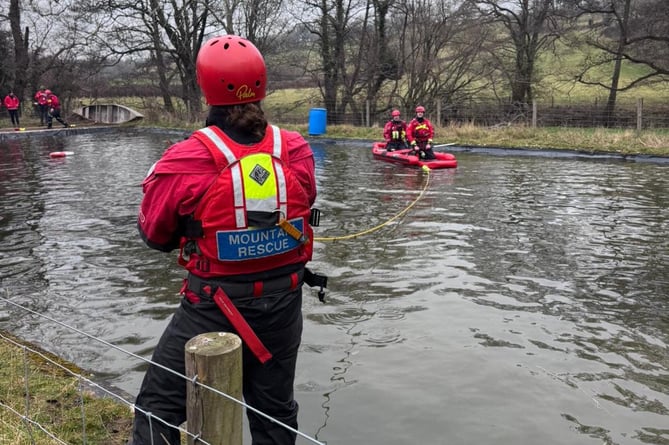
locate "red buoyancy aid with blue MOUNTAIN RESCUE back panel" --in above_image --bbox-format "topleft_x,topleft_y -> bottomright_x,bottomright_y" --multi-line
179,126 -> 313,277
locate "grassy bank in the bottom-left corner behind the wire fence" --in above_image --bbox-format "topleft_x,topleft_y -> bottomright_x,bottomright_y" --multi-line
0,331 -> 132,445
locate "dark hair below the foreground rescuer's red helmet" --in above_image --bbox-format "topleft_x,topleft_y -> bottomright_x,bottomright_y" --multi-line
206,102 -> 267,144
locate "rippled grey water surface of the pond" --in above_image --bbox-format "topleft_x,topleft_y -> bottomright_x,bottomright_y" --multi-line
0,133 -> 669,445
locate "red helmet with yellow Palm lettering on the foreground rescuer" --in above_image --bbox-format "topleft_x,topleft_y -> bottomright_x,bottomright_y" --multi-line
195,36 -> 267,105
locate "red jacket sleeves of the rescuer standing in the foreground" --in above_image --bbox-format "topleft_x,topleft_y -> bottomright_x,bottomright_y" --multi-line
138,125 -> 316,274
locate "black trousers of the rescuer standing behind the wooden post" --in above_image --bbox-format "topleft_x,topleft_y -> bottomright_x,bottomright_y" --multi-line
130,284 -> 302,445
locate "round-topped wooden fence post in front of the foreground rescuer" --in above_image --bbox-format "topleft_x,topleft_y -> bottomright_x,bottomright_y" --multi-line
185,332 -> 243,445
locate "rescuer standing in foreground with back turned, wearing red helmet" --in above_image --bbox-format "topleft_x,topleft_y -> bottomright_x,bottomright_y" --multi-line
129,35 -> 316,445
